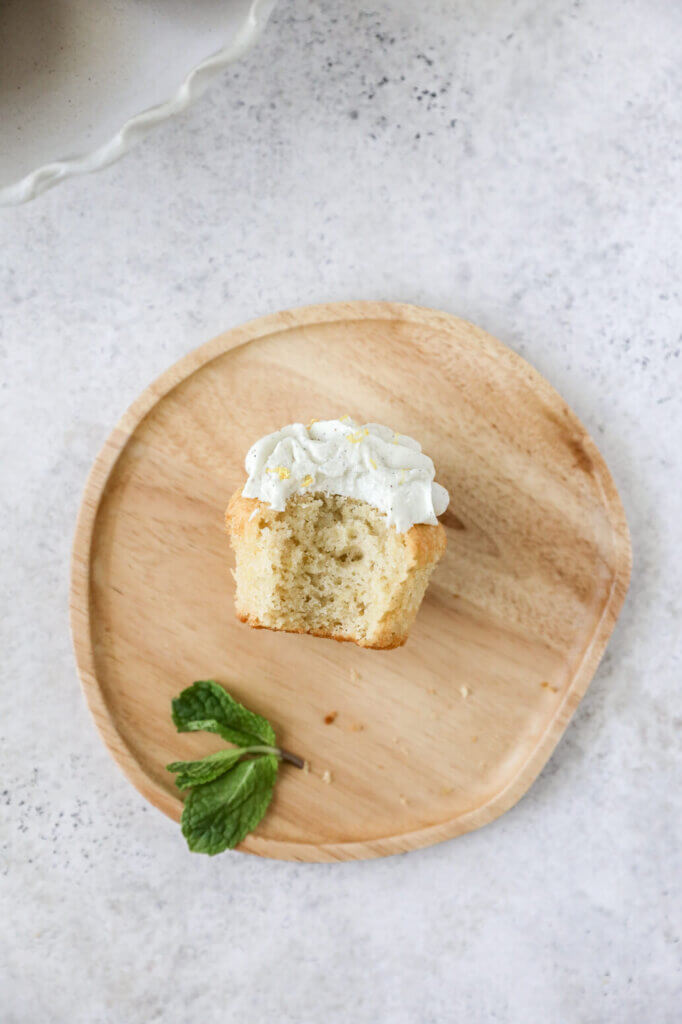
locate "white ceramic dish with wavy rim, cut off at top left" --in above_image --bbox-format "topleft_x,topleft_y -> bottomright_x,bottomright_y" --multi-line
0,0 -> 275,205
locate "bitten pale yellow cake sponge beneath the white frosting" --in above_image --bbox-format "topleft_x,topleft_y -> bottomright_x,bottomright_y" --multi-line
225,489 -> 445,649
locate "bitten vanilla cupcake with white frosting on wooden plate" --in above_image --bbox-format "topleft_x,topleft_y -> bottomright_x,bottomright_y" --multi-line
225,417 -> 450,649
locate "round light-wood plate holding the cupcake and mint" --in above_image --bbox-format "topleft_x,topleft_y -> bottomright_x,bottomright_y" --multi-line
71,302 -> 631,860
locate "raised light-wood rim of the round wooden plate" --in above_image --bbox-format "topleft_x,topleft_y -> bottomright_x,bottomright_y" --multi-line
69,300 -> 632,862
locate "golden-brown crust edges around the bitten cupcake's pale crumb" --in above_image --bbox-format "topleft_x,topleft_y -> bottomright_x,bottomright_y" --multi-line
225,488 -> 446,650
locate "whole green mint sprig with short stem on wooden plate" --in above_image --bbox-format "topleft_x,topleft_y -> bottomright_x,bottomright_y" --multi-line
167,679 -> 304,856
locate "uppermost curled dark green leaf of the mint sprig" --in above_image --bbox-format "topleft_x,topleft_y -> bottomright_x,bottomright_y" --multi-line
173,679 -> 274,746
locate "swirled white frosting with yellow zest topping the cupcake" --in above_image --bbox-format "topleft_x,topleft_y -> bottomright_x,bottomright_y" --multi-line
243,417 -> 450,534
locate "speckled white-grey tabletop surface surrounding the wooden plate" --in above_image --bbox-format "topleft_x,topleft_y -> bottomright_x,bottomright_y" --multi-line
0,0 -> 682,1024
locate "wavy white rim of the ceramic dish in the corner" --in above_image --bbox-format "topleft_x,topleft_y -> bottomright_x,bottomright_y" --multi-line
0,0 -> 276,207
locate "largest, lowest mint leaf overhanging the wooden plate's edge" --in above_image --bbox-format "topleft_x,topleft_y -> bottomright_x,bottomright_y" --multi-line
181,755 -> 278,856
